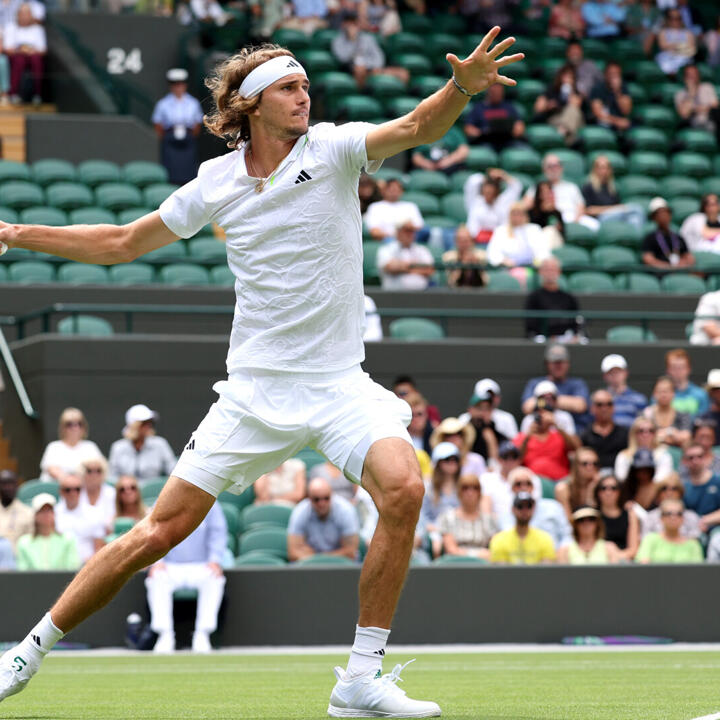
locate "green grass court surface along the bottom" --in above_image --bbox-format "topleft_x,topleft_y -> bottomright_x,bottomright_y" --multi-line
0,652 -> 720,720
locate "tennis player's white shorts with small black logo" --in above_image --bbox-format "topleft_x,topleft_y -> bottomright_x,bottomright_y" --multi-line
172,366 -> 412,497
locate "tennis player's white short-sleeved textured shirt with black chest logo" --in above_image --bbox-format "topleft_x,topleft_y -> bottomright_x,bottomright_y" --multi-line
160,122 -> 381,375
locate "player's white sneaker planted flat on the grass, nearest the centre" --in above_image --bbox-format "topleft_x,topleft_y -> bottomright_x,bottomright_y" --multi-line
328,660 -> 441,718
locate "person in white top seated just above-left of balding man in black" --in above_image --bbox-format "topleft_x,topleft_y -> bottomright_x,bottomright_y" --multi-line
487,202 -> 550,268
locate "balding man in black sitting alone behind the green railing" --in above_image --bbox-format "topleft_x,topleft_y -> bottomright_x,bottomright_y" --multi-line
525,255 -> 584,342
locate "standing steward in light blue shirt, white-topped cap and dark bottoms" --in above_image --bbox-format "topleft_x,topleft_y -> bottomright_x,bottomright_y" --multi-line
152,68 -> 204,185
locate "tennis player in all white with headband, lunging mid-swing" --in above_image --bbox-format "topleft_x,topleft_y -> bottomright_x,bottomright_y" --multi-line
0,27 -> 523,718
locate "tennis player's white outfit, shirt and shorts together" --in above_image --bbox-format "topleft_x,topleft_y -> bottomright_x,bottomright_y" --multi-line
160,123 -> 410,495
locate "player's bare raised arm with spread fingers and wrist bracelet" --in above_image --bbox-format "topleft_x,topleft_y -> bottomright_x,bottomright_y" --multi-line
365,26 -> 525,160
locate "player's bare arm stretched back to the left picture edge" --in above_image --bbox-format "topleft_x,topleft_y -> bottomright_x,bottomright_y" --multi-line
0,211 -> 178,265
